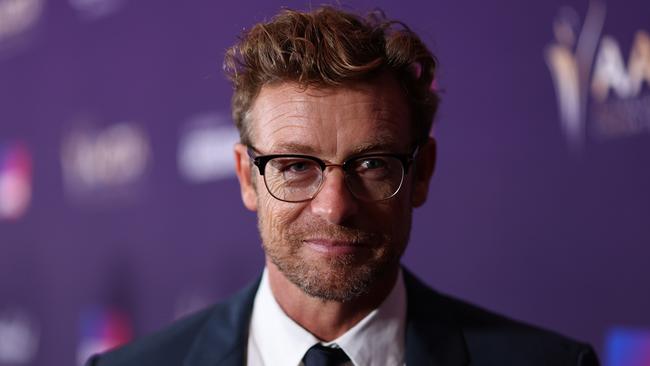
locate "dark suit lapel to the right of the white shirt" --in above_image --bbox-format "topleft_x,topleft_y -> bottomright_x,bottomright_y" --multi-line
404,269 -> 469,366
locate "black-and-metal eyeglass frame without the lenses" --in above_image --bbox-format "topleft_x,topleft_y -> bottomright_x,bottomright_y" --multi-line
246,145 -> 420,203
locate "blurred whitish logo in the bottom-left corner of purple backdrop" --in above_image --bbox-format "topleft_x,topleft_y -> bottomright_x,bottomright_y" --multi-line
0,309 -> 39,365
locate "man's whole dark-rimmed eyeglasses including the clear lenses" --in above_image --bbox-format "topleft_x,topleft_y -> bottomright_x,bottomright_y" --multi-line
248,146 -> 418,202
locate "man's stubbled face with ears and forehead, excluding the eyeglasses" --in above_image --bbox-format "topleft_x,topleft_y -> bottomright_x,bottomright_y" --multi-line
236,77 -> 432,302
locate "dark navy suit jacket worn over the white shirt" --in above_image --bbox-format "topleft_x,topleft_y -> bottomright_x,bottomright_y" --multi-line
87,271 -> 598,366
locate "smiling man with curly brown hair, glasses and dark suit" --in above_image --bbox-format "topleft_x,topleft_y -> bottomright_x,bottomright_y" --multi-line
89,7 -> 598,366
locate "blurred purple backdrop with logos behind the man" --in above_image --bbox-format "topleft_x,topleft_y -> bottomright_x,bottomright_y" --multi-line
0,0 -> 650,366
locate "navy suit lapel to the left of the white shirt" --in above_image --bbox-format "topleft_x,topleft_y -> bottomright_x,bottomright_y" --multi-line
184,279 -> 260,366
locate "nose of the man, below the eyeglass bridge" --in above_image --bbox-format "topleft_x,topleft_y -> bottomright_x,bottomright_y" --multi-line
310,167 -> 359,224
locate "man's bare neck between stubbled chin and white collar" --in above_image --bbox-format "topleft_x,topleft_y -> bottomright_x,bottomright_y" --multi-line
266,259 -> 399,342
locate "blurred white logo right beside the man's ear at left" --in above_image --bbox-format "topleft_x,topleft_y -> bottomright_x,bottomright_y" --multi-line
177,113 -> 239,183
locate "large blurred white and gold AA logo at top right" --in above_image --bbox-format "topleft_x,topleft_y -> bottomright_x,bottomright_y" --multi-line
545,1 -> 650,153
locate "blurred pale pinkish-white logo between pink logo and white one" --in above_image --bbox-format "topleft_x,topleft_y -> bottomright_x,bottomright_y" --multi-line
61,122 -> 151,202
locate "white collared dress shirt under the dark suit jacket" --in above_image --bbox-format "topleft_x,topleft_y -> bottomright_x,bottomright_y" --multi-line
247,269 -> 406,366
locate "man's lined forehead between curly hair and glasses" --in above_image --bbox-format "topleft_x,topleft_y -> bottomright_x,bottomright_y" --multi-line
249,77 -> 410,156
